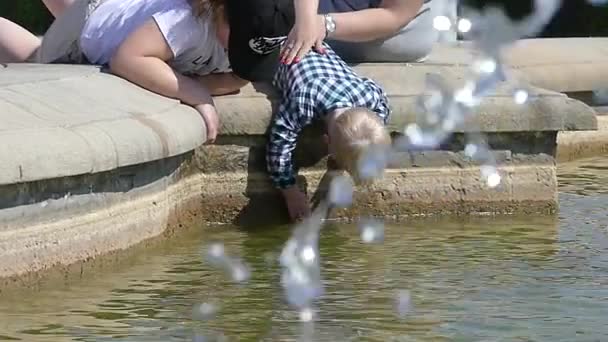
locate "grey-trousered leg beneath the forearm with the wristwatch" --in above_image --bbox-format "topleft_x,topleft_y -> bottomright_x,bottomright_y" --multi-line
329,0 -> 443,63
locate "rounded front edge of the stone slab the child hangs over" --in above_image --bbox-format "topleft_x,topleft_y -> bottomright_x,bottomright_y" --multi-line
215,88 -> 597,136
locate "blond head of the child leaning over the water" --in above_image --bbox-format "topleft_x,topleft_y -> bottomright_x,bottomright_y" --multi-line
327,108 -> 391,182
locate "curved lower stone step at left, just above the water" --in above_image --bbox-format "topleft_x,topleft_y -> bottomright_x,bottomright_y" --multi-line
0,160 -> 204,285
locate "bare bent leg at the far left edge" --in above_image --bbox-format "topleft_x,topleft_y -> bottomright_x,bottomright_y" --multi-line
0,17 -> 41,63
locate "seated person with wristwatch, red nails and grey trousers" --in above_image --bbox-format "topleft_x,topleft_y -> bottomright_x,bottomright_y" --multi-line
281,0 -> 445,64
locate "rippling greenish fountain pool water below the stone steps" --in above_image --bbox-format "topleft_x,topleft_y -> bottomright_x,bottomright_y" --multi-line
0,158 -> 608,341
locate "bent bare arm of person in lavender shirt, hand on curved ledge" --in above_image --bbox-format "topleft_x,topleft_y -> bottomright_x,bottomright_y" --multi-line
110,19 -> 219,141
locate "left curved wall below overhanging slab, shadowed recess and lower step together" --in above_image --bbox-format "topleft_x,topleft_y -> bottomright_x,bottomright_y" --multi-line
0,153 -> 204,280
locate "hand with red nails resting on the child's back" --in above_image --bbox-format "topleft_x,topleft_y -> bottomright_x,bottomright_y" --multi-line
281,14 -> 326,64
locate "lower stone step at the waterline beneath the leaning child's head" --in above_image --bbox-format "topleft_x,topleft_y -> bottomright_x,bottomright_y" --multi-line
201,162 -> 558,226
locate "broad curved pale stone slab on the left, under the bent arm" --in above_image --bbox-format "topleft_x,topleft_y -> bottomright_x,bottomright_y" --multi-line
0,65 -> 206,185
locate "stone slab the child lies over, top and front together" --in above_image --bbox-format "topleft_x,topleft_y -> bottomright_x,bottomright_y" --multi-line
216,79 -> 596,136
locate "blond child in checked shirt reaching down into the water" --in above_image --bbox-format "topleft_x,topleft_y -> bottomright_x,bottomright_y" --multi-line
267,44 -> 390,220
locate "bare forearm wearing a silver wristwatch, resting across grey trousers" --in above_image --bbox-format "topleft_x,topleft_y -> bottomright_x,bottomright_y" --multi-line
330,0 -> 423,42
